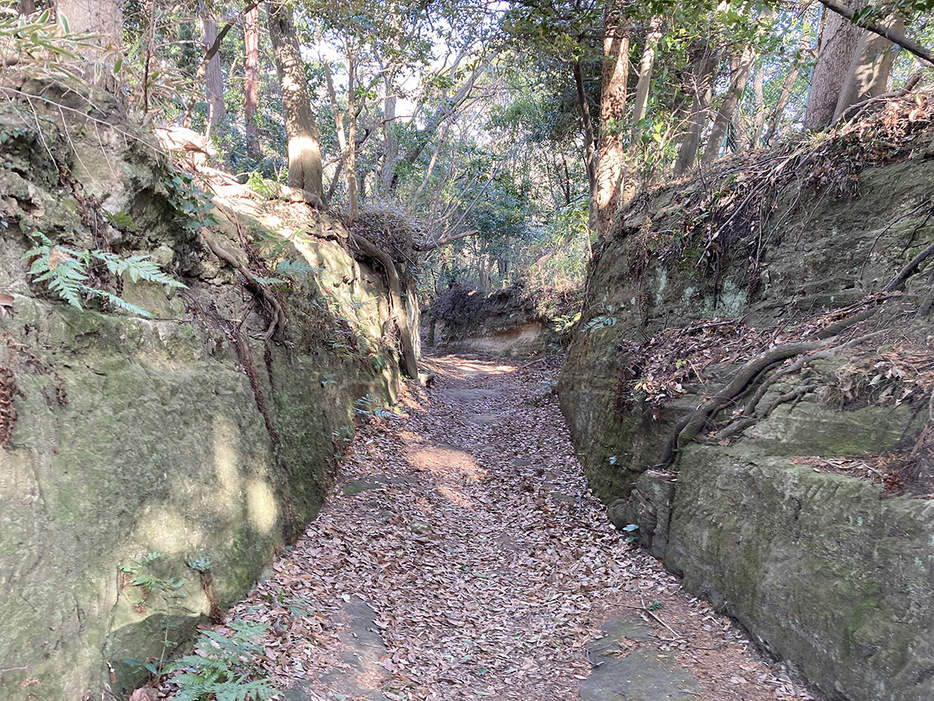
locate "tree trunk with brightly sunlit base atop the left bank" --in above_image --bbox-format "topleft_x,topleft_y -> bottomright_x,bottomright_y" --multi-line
266,2 -> 324,206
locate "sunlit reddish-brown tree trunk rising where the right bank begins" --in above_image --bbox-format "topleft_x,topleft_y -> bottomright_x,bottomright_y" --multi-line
596,0 -> 632,238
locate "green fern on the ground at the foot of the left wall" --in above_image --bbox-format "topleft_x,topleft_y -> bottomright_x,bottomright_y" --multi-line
166,621 -> 277,701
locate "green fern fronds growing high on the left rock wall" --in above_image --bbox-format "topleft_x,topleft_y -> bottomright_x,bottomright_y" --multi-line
23,231 -> 185,318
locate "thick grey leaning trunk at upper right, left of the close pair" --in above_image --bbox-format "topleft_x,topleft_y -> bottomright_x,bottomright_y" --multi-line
804,2 -> 864,129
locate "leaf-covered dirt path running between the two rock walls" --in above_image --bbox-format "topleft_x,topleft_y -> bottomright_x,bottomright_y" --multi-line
218,356 -> 811,701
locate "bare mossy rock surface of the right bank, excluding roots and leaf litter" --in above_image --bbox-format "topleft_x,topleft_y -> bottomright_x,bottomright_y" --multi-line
559,129 -> 934,701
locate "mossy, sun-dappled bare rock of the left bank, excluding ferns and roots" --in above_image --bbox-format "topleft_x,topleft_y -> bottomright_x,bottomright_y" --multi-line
0,86 -> 398,701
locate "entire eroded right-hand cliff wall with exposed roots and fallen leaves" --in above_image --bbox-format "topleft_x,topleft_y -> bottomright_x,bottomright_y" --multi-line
559,95 -> 934,700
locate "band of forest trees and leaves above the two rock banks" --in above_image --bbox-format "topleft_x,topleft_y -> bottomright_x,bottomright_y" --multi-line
7,0 -> 934,296
